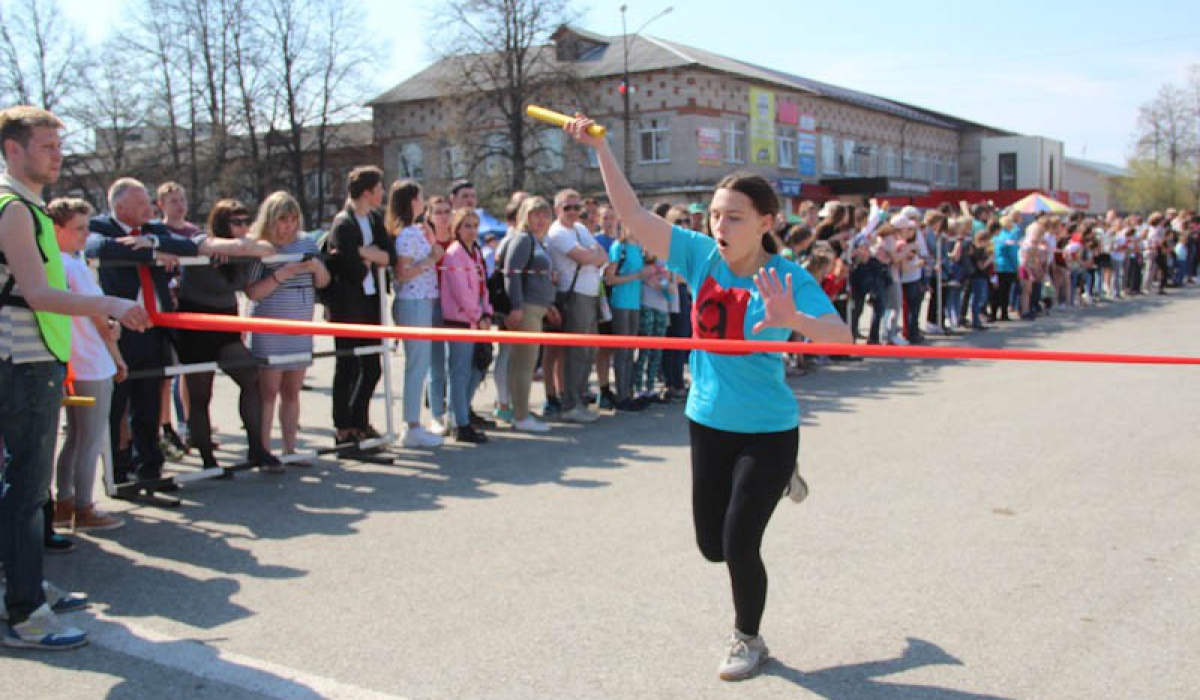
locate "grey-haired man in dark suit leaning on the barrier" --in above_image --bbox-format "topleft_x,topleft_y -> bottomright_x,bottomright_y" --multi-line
86,178 -> 251,483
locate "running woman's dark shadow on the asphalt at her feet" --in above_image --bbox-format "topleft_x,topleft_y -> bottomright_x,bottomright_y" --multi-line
762,638 -> 1022,700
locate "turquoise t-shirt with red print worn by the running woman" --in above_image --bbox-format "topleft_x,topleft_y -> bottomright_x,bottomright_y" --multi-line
667,226 -> 836,432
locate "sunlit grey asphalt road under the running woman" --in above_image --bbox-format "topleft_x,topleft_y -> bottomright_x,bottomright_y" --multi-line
0,289 -> 1200,700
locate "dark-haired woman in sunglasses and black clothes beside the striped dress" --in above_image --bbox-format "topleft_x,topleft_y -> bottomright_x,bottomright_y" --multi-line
176,199 -> 280,471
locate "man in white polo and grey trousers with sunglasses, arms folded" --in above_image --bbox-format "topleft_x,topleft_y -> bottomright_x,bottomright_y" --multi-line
547,190 -> 608,423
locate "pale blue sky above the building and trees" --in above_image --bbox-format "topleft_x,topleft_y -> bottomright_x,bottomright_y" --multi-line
60,0 -> 1200,164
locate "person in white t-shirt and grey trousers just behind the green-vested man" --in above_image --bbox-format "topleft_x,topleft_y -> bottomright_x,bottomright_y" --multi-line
46,199 -> 128,531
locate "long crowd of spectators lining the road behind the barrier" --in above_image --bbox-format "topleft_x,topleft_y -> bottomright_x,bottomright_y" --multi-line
28,167 -> 1200,542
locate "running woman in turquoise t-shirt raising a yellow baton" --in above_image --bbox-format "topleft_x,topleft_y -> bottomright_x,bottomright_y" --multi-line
564,115 -> 853,681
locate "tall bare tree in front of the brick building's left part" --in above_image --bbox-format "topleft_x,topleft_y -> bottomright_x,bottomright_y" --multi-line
431,0 -> 576,191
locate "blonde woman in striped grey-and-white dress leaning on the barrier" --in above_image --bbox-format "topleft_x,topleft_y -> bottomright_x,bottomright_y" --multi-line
246,192 -> 330,463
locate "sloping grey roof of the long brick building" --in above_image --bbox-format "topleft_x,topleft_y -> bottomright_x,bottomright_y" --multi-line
367,25 -> 974,133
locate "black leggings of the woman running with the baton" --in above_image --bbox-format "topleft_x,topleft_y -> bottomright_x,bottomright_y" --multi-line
689,421 -> 800,635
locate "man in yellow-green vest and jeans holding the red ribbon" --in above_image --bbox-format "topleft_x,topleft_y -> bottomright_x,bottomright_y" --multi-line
0,106 -> 150,650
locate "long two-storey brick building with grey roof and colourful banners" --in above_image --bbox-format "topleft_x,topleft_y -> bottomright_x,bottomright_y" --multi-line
370,26 -> 1009,211
